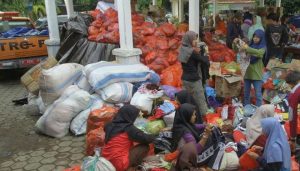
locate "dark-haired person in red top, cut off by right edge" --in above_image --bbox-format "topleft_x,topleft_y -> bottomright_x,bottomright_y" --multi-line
285,71 -> 300,146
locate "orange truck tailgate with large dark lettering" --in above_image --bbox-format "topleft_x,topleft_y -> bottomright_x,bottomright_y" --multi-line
0,36 -> 48,60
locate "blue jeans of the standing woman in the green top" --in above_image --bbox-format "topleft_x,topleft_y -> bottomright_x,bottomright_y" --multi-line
244,79 -> 263,106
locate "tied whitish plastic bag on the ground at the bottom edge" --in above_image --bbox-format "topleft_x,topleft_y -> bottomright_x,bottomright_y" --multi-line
81,148 -> 116,171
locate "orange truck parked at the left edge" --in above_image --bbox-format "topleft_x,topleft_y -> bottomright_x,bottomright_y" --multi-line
0,12 -> 49,70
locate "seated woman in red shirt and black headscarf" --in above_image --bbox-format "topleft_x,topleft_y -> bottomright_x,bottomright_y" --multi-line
102,105 -> 155,171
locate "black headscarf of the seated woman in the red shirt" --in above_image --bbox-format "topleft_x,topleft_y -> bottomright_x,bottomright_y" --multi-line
104,105 -> 140,143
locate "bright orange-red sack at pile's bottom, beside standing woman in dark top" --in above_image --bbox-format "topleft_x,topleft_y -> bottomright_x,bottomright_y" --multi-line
160,62 -> 182,87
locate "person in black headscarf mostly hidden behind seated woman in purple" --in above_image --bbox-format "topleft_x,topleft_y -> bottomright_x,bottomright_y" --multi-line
175,90 -> 203,123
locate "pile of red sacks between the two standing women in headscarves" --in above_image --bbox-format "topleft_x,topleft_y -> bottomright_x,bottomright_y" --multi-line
204,32 -> 236,63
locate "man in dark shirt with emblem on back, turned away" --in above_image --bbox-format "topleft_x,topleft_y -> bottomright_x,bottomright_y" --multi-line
264,13 -> 289,66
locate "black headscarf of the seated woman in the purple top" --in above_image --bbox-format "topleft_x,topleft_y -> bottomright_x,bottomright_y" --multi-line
172,103 -> 200,150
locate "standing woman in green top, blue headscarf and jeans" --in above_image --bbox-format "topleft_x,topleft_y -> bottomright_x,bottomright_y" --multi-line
234,30 -> 266,107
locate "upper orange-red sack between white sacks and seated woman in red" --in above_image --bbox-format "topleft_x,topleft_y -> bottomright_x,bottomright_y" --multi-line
87,106 -> 118,132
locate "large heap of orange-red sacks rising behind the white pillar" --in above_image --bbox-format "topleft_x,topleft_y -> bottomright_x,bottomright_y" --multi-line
88,8 -> 184,87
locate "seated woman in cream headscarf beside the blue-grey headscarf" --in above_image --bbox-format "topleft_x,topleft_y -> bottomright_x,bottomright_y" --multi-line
246,104 -> 275,146
